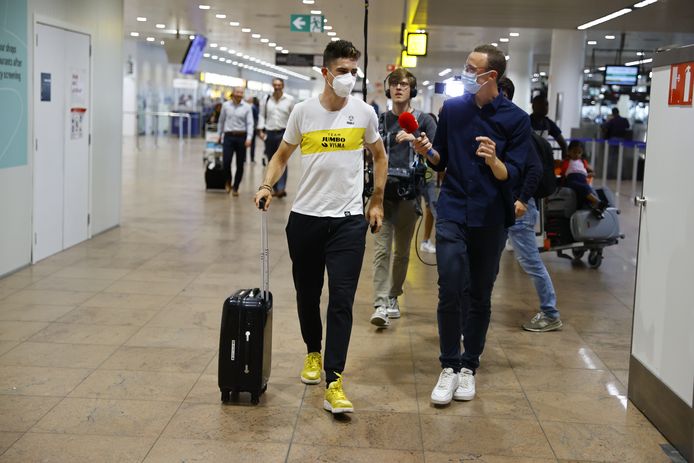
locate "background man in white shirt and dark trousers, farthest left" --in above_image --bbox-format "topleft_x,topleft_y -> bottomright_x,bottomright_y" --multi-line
217,87 -> 253,196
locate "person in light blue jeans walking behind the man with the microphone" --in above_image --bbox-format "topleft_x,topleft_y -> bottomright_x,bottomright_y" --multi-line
499,77 -> 563,332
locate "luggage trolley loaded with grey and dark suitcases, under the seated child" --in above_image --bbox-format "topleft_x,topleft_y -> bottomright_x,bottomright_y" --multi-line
539,187 -> 624,269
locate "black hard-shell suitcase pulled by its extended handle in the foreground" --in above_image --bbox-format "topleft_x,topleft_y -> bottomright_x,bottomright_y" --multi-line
218,201 -> 272,405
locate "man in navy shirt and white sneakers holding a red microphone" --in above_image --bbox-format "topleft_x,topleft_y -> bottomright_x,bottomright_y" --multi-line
414,45 -> 531,404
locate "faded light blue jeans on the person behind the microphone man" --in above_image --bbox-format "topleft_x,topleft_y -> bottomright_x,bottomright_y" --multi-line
508,199 -> 559,318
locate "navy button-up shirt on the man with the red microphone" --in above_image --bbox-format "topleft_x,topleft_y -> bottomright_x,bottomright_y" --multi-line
431,94 -> 531,227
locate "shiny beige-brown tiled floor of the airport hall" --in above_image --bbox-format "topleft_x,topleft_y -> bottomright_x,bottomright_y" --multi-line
0,136 -> 668,463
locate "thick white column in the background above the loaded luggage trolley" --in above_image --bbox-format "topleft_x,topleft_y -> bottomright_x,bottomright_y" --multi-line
547,29 -> 586,137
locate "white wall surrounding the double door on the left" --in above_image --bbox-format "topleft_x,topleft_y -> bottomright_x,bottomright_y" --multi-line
0,0 -> 123,275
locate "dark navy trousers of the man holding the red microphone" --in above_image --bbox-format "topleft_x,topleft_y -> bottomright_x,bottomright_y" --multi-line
436,219 -> 506,373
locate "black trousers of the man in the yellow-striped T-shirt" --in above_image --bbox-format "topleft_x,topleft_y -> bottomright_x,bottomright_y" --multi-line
286,212 -> 368,386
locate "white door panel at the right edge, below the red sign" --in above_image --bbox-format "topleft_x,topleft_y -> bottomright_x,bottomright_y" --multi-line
629,59 -> 694,406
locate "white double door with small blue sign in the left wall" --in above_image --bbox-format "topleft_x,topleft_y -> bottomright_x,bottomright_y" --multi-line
32,23 -> 90,262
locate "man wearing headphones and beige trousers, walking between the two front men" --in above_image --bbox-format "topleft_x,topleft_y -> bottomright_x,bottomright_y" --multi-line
371,68 -> 436,328
